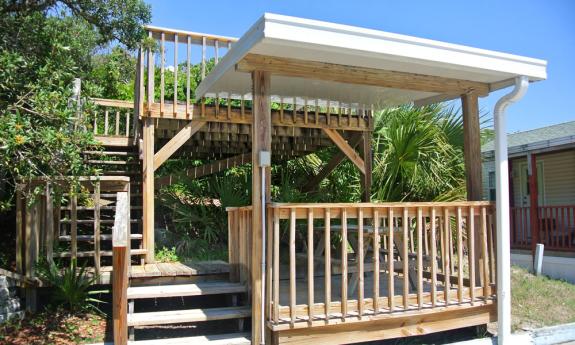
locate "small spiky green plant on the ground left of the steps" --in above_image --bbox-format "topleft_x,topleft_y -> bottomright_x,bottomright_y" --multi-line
38,259 -> 104,312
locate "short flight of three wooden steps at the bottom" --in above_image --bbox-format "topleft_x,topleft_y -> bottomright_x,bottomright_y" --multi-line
127,281 -> 251,345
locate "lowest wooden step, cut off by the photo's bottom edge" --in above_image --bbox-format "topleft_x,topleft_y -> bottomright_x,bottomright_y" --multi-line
128,333 -> 251,345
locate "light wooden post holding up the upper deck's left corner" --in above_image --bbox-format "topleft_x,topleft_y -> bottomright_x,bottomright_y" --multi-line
142,117 -> 155,263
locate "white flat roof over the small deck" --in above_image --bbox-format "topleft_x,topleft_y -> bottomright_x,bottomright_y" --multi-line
196,13 -> 547,97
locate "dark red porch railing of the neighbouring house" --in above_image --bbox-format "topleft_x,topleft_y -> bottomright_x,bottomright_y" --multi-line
511,205 -> 575,251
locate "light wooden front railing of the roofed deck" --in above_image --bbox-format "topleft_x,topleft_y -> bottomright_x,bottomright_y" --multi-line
264,202 -> 496,330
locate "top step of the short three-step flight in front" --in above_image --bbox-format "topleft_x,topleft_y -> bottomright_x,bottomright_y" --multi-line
128,282 -> 247,299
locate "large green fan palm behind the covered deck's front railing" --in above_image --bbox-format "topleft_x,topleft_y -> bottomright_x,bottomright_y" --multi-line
372,105 -> 465,201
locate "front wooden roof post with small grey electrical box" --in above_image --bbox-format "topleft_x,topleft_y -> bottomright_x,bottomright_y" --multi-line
251,71 -> 272,345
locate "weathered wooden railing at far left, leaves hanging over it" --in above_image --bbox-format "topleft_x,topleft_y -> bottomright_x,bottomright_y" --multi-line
16,176 -> 134,279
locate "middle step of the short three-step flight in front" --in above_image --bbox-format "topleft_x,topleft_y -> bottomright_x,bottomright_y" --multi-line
128,307 -> 252,327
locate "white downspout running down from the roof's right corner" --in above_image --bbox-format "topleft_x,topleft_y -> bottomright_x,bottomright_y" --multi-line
493,76 -> 529,345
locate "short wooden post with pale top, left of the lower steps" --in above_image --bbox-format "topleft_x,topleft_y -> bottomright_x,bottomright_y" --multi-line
112,192 -> 130,345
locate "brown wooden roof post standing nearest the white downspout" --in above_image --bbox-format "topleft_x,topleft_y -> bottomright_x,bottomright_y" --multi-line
461,93 -> 483,280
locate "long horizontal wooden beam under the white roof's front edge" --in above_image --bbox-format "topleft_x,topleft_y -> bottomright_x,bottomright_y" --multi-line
236,54 -> 489,95
